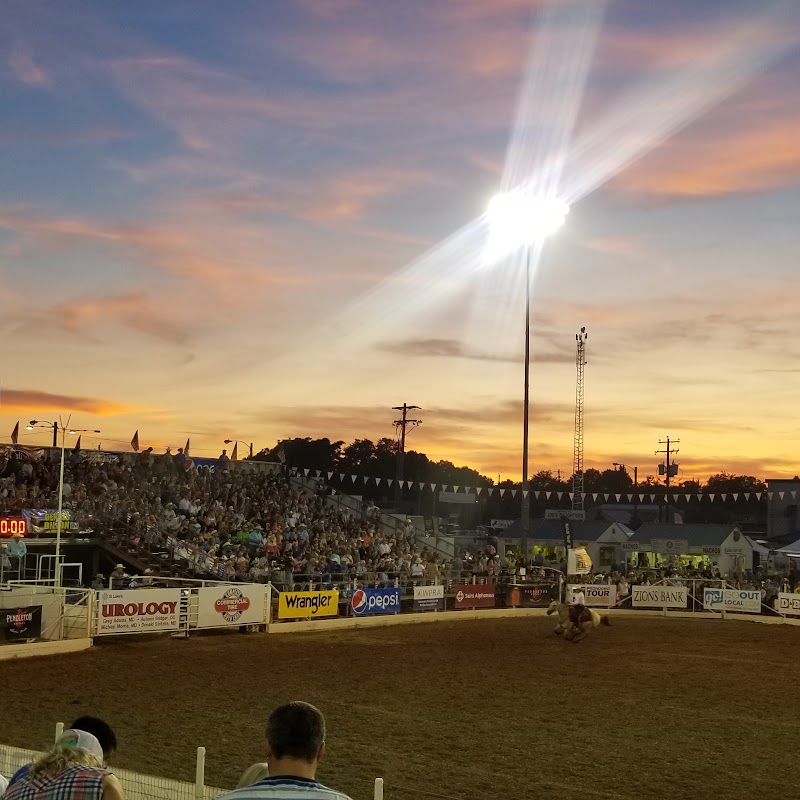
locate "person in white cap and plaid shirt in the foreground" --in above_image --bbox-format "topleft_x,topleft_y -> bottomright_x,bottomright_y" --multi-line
5,728 -> 124,800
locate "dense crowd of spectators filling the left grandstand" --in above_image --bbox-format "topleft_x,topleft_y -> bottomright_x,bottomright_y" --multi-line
0,452 -> 460,589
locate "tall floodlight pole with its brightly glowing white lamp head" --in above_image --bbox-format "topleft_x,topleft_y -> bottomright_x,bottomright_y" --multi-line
486,190 -> 569,564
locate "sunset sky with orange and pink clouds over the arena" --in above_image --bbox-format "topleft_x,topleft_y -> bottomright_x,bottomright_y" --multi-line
0,0 -> 800,479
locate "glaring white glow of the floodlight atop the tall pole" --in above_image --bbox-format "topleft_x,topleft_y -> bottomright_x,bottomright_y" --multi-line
485,190 -> 569,264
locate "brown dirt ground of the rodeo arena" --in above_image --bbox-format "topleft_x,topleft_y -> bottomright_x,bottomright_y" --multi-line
0,617 -> 800,800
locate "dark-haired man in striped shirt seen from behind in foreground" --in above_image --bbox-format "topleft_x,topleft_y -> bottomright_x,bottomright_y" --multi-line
217,701 -> 350,800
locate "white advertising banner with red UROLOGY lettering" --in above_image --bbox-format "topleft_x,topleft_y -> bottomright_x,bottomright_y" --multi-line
97,589 -> 181,634
